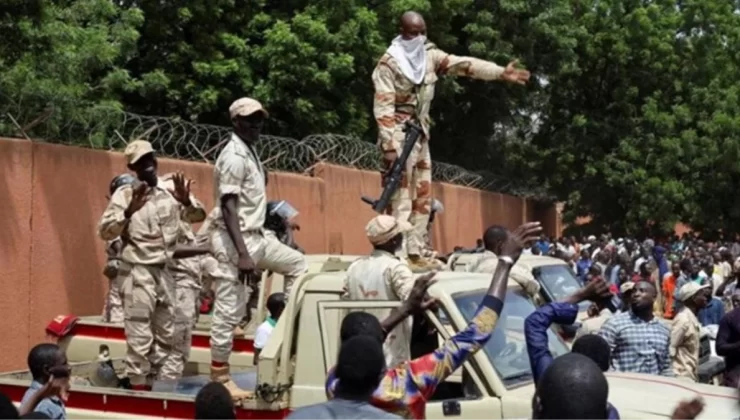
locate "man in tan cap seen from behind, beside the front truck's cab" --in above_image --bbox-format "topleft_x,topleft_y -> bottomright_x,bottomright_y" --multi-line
345,215 -> 414,366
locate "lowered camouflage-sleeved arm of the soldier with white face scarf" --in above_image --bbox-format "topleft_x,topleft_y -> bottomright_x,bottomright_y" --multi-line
372,61 -> 398,153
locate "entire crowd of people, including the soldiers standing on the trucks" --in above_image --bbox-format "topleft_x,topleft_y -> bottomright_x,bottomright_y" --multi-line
2,12 -> 740,420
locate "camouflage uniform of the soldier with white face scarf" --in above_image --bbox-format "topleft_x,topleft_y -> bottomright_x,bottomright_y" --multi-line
372,43 -> 505,256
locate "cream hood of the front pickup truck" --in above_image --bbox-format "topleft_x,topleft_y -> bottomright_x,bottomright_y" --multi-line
504,372 -> 740,420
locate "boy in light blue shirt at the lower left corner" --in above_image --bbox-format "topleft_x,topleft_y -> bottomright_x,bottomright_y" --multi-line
21,343 -> 70,420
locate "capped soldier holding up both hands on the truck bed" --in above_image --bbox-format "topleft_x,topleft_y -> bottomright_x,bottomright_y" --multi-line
98,140 -> 206,390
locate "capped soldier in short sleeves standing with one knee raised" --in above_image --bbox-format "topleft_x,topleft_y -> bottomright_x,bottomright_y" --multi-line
208,98 -> 306,400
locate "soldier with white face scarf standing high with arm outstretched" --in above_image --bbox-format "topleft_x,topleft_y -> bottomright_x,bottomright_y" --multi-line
372,12 -> 529,266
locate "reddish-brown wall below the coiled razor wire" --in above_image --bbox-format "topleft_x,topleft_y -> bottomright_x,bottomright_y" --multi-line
0,139 -> 558,371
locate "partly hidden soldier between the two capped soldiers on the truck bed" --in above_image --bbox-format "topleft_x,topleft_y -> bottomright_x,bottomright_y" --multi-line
167,221 -> 224,377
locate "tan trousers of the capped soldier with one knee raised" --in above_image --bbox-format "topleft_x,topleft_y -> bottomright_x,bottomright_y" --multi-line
210,230 -> 307,363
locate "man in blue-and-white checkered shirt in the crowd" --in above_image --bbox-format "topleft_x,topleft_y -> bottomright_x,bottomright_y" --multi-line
599,281 -> 675,376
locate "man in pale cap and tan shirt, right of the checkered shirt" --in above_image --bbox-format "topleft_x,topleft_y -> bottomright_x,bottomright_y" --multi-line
670,282 -> 712,381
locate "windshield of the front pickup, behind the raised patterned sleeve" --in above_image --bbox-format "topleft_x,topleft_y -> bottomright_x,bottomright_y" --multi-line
452,290 -> 568,388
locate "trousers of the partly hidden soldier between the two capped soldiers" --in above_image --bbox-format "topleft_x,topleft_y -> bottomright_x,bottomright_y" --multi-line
172,285 -> 200,376
